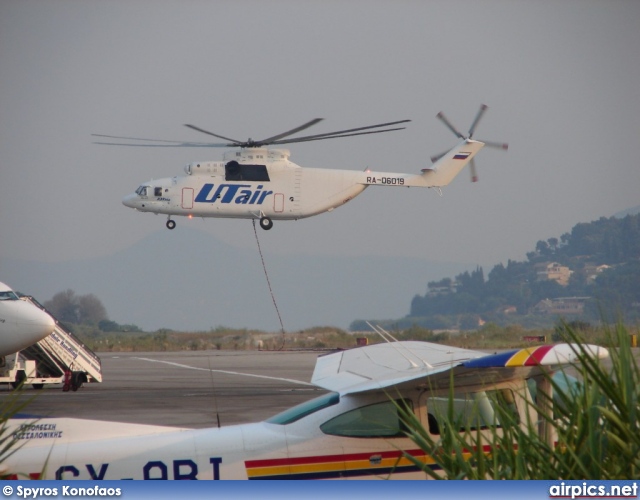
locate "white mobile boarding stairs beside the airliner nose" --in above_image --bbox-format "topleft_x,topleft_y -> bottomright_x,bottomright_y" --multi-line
0,297 -> 102,392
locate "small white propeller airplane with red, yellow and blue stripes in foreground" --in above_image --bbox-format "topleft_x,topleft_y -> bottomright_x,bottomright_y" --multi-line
2,341 -> 608,480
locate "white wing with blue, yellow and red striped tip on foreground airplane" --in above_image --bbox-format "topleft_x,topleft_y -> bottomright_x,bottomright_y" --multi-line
311,341 -> 609,395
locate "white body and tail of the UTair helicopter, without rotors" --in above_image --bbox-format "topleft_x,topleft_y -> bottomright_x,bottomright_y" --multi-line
122,140 -> 484,229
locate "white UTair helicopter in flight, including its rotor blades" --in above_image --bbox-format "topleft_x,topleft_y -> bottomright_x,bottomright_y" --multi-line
92,104 -> 508,230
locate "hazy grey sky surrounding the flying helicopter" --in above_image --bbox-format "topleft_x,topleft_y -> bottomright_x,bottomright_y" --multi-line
0,0 -> 640,324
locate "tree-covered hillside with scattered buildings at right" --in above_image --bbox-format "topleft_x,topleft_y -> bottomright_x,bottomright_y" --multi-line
351,213 -> 640,330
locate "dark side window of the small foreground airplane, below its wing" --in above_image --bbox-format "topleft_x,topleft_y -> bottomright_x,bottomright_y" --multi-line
320,399 -> 413,438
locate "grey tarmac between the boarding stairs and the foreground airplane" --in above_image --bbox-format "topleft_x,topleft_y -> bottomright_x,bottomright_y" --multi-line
0,351 -> 325,428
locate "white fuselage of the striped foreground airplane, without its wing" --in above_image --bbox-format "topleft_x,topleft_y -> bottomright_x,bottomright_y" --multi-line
7,380 -> 527,480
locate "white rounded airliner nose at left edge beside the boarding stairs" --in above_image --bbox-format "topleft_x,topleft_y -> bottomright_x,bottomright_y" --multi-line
0,283 -> 55,356
